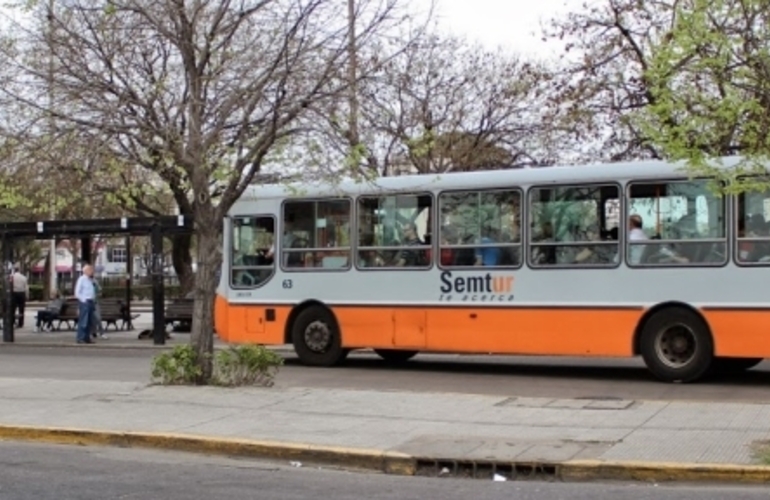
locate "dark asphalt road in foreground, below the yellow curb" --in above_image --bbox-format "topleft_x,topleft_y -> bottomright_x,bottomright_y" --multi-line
0,442 -> 767,500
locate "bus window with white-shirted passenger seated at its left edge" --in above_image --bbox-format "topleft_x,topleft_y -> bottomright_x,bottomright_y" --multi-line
626,180 -> 727,267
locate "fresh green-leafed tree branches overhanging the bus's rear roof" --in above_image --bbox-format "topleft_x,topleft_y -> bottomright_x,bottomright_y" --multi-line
635,0 -> 770,193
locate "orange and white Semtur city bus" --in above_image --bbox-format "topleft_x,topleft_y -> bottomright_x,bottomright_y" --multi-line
215,158 -> 770,382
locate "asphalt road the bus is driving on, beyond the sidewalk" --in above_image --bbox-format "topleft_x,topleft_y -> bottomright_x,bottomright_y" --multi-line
0,345 -> 770,402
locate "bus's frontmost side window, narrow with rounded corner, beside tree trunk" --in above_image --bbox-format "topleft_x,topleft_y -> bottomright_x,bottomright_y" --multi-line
230,216 -> 275,288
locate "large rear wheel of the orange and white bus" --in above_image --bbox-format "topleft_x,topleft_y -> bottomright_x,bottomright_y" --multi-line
640,307 -> 714,382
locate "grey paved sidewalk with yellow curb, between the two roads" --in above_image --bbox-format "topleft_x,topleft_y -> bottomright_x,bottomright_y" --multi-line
0,374 -> 770,482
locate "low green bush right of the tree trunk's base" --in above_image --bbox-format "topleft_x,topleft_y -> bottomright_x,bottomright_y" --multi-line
214,344 -> 283,387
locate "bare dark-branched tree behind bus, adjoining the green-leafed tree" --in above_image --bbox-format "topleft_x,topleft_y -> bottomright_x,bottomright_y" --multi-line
545,0 -> 677,160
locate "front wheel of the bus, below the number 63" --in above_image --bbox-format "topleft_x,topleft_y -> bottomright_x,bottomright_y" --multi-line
291,306 -> 348,366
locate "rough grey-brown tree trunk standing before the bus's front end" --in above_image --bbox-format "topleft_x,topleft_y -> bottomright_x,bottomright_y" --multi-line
190,214 -> 222,384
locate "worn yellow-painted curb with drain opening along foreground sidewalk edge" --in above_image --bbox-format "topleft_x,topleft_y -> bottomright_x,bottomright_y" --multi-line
0,425 -> 770,484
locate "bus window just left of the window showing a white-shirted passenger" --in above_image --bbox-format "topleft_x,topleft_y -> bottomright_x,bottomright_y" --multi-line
529,185 -> 620,268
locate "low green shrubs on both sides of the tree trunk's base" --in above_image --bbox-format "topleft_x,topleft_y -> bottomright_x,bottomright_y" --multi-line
152,344 -> 283,387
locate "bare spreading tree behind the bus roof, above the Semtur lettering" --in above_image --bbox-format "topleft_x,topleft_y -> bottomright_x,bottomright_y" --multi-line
306,33 -> 550,175
